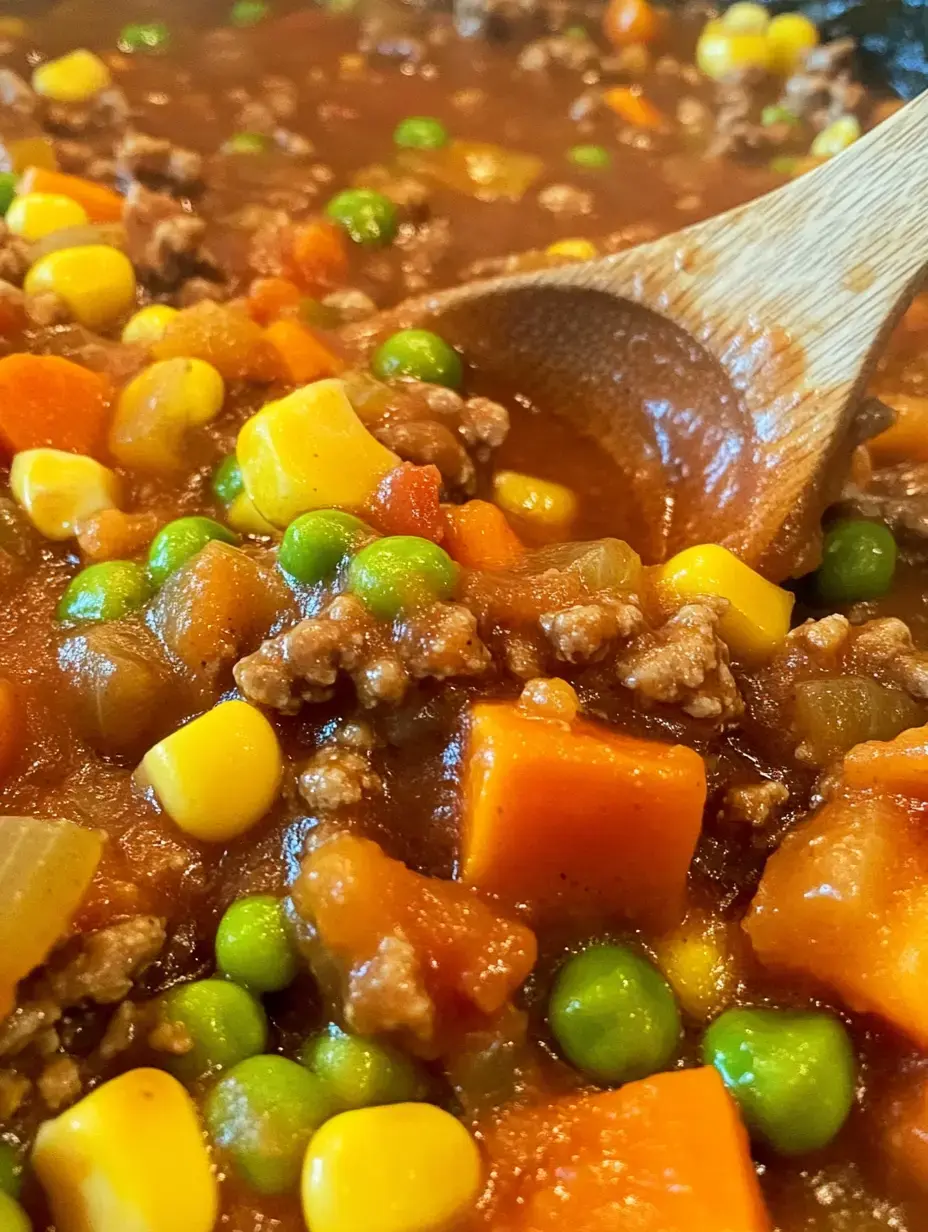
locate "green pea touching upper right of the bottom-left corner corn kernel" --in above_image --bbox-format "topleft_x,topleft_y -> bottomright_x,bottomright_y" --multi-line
161,979 -> 267,1080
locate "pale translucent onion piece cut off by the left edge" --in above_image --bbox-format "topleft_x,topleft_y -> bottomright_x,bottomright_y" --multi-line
0,817 -> 104,1018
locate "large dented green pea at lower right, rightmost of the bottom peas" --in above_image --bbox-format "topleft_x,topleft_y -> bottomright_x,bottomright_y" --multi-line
702,1009 -> 857,1154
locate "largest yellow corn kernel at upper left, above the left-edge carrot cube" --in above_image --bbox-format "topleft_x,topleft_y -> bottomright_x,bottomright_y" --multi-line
23,244 -> 136,330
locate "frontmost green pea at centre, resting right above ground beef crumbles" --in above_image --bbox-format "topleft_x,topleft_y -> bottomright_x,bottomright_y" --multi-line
348,535 -> 457,620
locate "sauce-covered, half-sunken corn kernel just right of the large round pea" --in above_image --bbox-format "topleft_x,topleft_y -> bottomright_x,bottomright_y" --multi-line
654,915 -> 738,1023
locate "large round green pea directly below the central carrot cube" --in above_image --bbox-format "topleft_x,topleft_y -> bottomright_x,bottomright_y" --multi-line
547,945 -> 680,1083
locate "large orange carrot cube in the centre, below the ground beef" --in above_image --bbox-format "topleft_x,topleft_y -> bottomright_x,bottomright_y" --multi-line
461,702 -> 706,928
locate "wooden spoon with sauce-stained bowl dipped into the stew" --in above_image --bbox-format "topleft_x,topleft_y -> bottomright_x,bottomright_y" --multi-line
352,94 -> 928,579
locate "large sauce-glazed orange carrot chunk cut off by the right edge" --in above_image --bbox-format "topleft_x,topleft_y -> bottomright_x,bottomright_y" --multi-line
744,793 -> 928,1047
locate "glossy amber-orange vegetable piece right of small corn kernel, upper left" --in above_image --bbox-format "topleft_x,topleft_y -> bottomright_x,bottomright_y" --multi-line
152,299 -> 281,381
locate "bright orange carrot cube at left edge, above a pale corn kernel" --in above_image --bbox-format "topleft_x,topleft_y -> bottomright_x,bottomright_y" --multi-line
0,354 -> 111,456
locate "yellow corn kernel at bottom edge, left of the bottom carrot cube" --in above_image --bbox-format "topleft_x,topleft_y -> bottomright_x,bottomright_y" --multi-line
302,1104 -> 481,1232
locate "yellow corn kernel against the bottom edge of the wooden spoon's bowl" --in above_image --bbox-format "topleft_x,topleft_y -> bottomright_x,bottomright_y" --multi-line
654,543 -> 794,658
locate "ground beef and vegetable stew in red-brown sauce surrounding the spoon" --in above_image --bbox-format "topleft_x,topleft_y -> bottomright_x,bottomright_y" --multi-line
0,0 -> 928,1232
